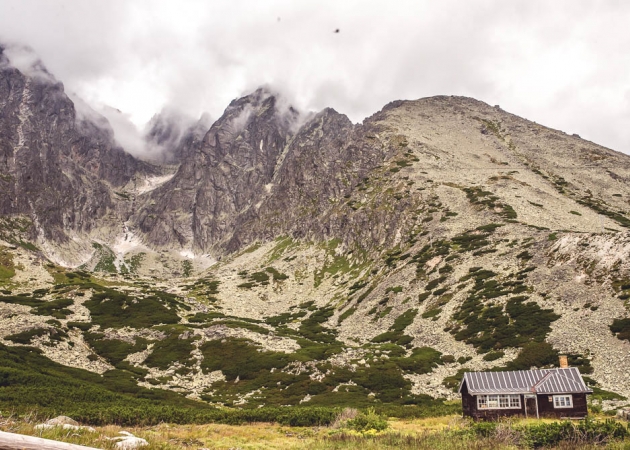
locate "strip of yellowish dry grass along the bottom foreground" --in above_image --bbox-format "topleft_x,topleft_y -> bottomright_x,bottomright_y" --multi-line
0,411 -> 630,450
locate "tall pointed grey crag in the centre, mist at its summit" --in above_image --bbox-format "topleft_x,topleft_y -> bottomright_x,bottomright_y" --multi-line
135,89 -> 304,251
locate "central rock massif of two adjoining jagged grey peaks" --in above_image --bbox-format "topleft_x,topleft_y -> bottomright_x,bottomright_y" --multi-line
137,90 -> 424,255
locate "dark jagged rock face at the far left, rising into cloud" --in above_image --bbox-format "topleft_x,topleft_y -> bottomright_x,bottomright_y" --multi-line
0,48 -> 147,241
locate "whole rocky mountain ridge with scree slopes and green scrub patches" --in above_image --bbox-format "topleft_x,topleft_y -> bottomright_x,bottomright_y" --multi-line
0,44 -> 630,407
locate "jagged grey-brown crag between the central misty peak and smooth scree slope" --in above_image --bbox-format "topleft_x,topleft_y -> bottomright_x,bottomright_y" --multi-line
226,109 -> 413,251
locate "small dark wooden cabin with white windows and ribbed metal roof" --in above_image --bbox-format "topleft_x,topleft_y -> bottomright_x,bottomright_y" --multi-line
459,367 -> 593,420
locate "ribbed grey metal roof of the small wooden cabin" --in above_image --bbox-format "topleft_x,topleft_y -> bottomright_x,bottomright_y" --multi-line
459,367 -> 593,394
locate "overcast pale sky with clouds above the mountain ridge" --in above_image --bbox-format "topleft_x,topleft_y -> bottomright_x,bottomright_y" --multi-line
0,0 -> 630,153
